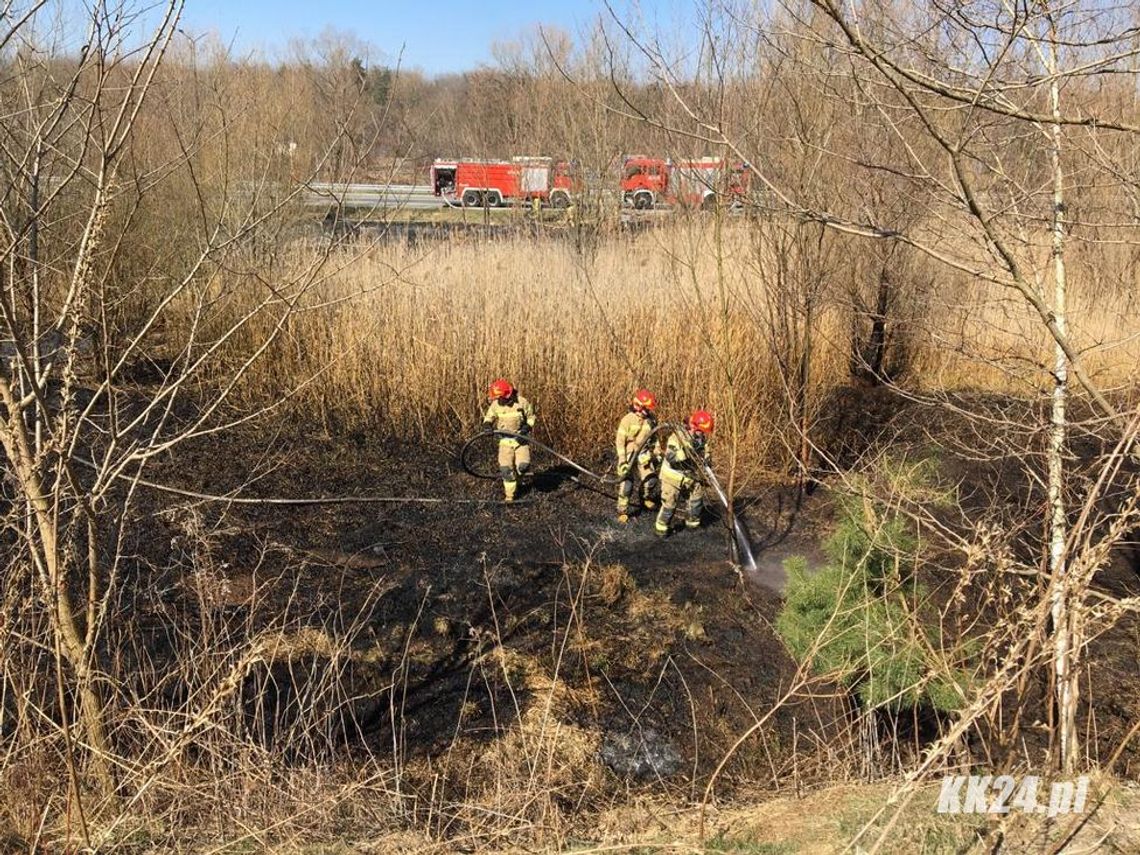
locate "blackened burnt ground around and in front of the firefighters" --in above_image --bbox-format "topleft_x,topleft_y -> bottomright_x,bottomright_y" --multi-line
122,396 -> 1140,798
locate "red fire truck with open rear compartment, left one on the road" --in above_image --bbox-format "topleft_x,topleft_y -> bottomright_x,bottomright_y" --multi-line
431,157 -> 573,207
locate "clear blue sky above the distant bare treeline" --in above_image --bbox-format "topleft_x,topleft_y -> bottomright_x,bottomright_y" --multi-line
173,0 -> 605,75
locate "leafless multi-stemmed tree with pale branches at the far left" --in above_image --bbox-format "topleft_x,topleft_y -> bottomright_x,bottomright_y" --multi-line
0,0 -> 373,816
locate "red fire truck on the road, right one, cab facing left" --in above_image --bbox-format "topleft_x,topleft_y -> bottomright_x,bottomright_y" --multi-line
621,155 -> 750,210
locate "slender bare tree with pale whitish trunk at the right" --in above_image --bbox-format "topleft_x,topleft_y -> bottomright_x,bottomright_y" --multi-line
798,0 -> 1135,772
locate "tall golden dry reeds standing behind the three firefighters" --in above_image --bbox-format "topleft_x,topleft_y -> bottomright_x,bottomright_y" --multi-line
226,218 -> 1140,469
